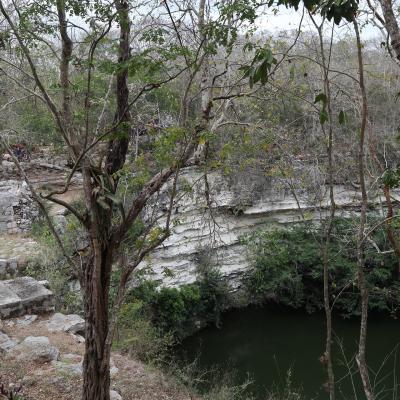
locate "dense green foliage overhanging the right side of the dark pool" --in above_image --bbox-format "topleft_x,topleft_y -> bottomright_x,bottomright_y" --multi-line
243,219 -> 400,316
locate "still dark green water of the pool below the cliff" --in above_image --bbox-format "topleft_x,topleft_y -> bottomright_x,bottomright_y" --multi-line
181,308 -> 400,400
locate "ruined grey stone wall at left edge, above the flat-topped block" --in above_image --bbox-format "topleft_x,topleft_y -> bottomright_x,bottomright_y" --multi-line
0,180 -> 38,234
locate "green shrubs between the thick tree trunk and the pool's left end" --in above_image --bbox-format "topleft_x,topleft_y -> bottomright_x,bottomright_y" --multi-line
118,260 -> 228,358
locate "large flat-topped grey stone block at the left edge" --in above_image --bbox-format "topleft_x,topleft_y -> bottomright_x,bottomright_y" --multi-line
0,277 -> 54,318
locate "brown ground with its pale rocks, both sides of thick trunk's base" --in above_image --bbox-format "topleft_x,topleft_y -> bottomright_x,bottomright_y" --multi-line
0,313 -> 195,400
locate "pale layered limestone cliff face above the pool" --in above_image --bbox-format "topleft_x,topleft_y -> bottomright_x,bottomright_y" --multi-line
139,168 -> 390,290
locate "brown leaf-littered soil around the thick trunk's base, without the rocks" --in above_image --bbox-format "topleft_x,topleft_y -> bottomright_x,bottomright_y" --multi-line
0,316 -> 196,400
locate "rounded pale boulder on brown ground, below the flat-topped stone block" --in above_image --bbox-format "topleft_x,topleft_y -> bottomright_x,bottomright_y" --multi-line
9,336 -> 60,363
